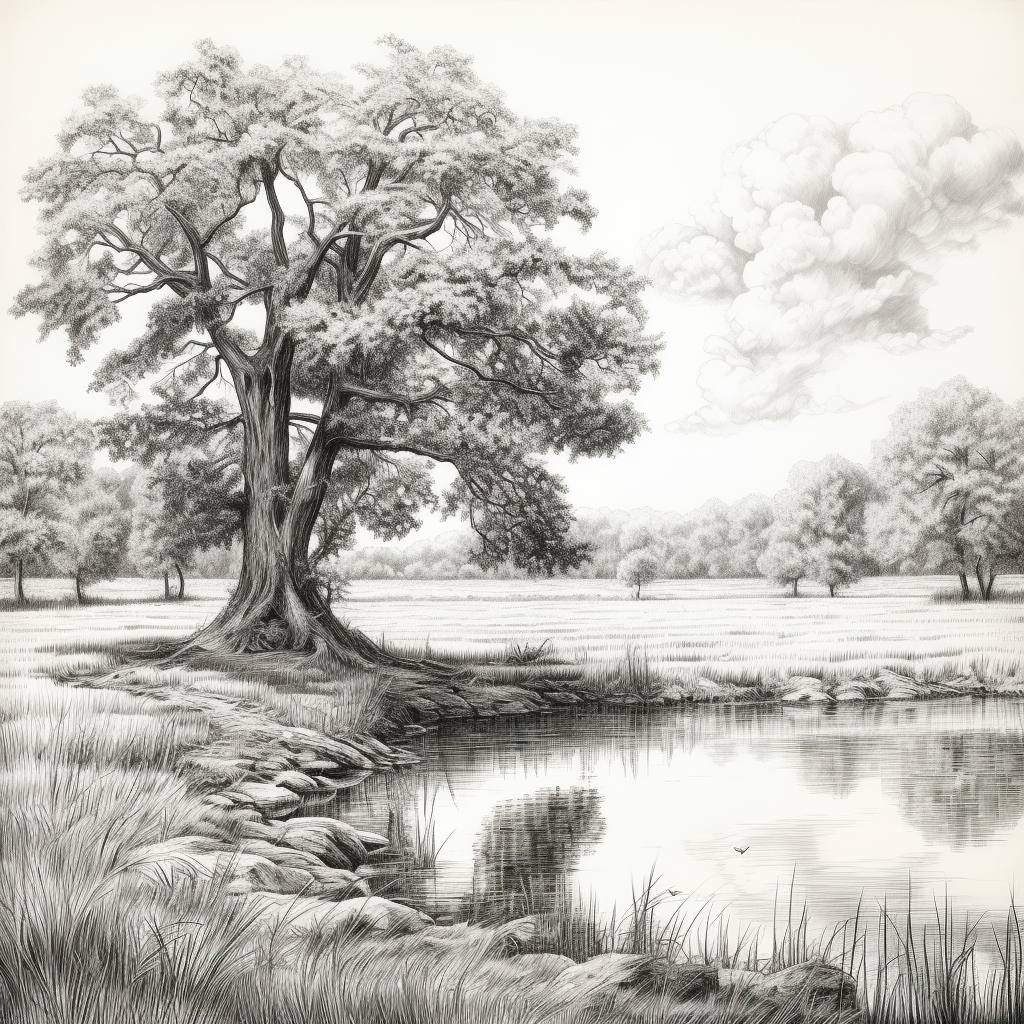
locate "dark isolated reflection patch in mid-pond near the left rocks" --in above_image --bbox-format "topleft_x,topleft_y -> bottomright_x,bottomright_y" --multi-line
473,785 -> 605,913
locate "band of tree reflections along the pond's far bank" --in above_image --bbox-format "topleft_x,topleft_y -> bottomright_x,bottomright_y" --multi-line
413,701 -> 1024,860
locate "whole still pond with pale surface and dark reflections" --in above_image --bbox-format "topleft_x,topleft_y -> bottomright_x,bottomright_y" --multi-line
310,699 -> 1024,954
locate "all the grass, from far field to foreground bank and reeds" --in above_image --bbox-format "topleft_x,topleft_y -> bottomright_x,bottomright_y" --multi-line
0,579 -> 1024,1024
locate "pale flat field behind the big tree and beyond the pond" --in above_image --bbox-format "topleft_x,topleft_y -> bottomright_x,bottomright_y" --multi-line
0,577 -> 1024,685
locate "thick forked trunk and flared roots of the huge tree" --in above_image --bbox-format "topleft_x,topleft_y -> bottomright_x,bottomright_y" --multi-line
186,366 -> 385,664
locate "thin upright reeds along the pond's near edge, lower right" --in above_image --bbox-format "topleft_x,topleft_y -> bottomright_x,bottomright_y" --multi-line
499,868 -> 1024,1024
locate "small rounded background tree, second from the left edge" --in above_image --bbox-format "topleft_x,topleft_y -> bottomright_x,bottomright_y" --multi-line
50,470 -> 131,604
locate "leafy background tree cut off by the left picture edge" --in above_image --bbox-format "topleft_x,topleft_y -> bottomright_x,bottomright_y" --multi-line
0,401 -> 92,603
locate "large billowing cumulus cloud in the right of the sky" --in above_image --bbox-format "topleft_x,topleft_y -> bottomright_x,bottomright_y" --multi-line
639,94 -> 1024,433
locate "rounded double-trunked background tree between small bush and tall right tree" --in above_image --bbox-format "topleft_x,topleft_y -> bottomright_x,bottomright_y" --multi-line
758,456 -> 873,597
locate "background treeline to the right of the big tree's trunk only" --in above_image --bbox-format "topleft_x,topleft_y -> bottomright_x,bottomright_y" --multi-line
338,377 -> 1024,599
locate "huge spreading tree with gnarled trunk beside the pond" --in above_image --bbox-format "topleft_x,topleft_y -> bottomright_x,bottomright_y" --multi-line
16,38 -> 658,657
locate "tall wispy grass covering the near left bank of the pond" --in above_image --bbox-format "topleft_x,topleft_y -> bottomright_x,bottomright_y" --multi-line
0,687 -> 630,1024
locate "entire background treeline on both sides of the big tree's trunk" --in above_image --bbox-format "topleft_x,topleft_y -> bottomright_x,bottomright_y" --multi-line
0,377 -> 1024,600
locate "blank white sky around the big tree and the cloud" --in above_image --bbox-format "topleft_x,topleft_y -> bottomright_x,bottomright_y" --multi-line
0,0 -> 1024,532
